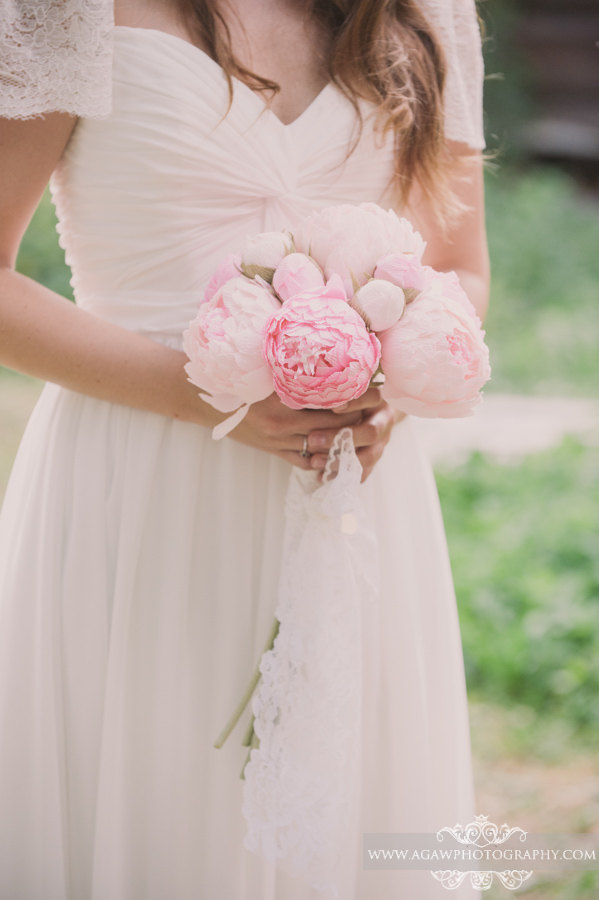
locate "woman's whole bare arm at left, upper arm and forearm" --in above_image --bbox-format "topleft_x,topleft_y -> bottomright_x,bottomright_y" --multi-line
0,113 -> 222,425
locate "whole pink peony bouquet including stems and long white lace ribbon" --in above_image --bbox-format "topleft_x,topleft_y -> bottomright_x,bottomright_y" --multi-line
183,204 -> 490,896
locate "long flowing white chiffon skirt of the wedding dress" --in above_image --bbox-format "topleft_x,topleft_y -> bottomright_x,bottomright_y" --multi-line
0,385 -> 479,900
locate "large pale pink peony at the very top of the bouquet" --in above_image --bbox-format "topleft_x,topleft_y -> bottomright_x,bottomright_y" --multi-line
294,203 -> 426,297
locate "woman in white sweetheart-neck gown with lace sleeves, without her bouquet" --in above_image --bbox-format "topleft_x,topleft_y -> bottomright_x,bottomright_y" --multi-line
0,0 -> 488,900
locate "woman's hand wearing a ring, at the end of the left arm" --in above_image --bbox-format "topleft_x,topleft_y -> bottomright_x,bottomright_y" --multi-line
229,394 -> 367,469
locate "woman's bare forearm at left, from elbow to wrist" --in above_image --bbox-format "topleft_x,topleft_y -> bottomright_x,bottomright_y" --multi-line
0,268 -> 223,427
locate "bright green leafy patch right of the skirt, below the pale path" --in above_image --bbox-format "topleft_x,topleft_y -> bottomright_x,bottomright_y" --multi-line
437,438 -> 599,737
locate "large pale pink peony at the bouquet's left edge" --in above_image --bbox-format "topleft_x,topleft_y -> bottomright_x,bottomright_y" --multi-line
183,277 -> 280,412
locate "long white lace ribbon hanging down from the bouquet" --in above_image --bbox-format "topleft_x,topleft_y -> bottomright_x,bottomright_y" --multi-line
243,428 -> 378,897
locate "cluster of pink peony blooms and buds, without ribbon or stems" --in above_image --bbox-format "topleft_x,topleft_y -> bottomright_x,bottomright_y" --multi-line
183,203 -> 490,438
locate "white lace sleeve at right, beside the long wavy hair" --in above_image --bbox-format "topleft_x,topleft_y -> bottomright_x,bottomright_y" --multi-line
419,0 -> 485,150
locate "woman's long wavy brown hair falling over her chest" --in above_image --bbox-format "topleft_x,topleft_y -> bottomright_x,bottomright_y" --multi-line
177,0 -> 459,220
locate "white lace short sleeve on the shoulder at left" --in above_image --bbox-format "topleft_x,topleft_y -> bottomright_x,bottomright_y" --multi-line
0,0 -> 114,119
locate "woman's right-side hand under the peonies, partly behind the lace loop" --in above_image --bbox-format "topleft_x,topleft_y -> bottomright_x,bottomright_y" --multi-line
308,387 -> 406,481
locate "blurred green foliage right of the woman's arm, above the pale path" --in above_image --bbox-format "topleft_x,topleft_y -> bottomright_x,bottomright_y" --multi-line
485,168 -> 599,395
